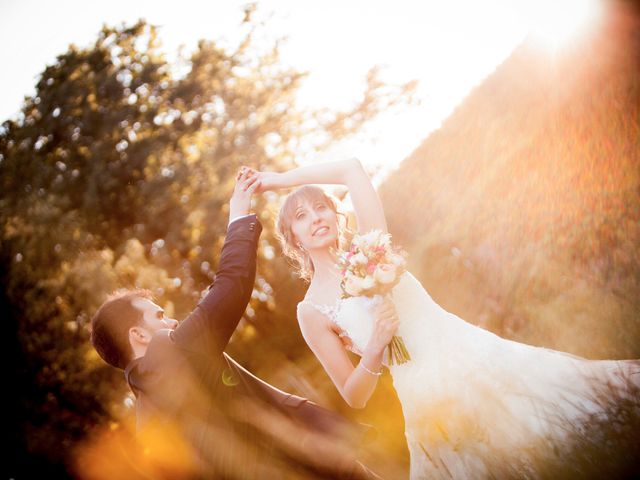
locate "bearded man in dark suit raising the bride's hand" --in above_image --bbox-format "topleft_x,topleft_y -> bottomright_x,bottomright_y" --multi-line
91,169 -> 379,479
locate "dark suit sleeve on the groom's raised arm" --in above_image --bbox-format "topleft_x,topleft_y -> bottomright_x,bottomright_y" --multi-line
172,215 -> 262,356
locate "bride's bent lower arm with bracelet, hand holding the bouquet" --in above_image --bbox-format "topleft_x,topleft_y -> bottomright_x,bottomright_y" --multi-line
298,304 -> 398,408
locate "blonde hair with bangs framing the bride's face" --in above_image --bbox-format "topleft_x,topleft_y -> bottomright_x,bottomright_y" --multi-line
276,185 -> 346,281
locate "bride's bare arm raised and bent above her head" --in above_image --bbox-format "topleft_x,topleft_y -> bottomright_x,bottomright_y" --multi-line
258,159 -> 387,233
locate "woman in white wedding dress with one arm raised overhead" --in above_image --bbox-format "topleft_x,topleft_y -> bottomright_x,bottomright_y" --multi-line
248,160 -> 640,479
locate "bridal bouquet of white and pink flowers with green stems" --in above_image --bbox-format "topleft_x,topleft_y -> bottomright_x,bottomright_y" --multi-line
338,230 -> 411,365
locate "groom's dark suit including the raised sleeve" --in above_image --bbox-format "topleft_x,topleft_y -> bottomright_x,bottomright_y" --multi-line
125,215 -> 374,478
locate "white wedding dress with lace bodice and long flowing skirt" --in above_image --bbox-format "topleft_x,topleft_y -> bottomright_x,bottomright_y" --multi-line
301,273 -> 640,479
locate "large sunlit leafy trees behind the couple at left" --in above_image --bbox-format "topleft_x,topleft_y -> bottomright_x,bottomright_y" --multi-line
0,14 -> 414,474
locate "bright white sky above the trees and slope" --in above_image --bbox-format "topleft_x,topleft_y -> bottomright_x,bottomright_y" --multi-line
0,0 -> 596,171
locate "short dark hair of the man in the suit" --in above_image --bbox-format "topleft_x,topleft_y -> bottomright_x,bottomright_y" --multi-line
91,290 -> 153,370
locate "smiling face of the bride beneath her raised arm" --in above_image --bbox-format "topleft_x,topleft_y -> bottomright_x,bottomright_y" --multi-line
291,200 -> 338,251
